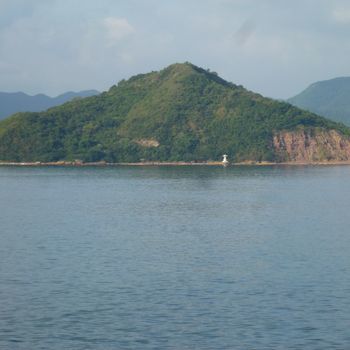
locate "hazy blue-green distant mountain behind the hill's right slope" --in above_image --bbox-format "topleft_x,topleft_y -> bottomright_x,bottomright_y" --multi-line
288,77 -> 350,126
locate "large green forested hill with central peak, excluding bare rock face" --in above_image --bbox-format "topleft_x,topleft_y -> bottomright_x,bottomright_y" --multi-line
0,63 -> 350,162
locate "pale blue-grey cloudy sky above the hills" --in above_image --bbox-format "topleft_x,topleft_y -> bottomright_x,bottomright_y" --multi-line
0,0 -> 350,98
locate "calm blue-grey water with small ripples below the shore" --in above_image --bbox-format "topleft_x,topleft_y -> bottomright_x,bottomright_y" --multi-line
0,166 -> 350,350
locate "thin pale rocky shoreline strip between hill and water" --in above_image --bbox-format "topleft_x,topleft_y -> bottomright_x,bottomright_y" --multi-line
0,160 -> 350,167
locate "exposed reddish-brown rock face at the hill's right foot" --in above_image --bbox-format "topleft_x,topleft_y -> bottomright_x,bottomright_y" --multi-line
273,129 -> 350,162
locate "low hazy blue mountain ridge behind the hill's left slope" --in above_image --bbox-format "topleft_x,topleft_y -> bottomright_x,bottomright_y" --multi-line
0,90 -> 99,119
